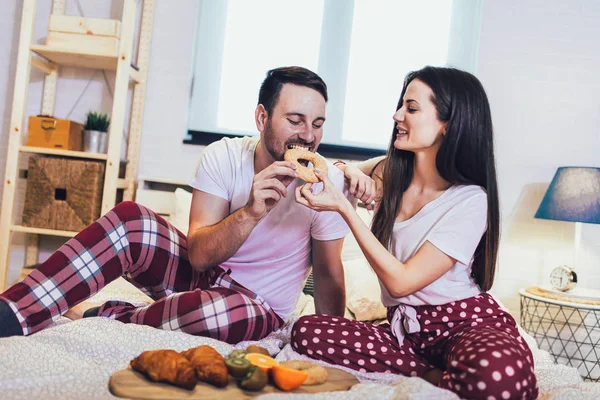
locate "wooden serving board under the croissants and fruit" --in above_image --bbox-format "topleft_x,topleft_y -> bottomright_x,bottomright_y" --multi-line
108,368 -> 358,400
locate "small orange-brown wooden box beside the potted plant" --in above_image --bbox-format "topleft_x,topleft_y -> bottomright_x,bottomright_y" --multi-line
25,117 -> 83,151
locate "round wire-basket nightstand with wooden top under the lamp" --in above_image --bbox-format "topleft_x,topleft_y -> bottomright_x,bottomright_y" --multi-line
519,288 -> 600,382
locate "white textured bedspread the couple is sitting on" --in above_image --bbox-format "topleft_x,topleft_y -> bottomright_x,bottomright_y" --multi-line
0,280 -> 600,400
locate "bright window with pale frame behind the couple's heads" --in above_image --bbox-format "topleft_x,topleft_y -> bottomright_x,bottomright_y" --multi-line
188,0 -> 481,149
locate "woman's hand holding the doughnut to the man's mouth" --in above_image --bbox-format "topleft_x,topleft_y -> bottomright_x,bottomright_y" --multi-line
296,169 -> 351,212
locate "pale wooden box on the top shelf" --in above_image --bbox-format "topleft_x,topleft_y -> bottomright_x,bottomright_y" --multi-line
46,15 -> 121,56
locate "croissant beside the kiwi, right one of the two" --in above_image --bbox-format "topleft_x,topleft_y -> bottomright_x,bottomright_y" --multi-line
182,346 -> 229,387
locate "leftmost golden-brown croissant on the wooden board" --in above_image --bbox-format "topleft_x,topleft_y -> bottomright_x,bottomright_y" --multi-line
130,350 -> 197,390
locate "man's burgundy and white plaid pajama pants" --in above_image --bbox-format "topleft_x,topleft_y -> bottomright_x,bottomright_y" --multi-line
0,202 -> 283,343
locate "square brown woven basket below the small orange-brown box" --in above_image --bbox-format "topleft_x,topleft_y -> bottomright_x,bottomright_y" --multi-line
22,156 -> 105,232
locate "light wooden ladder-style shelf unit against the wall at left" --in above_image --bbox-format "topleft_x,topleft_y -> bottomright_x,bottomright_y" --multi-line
0,0 -> 155,291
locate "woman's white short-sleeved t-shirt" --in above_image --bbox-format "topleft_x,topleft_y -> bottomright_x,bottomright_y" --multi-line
380,185 -> 487,307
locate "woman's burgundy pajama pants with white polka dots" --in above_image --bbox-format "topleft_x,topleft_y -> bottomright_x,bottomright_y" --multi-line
291,293 -> 537,399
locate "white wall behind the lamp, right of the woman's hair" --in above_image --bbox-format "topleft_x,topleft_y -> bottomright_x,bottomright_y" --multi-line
477,0 -> 600,316
